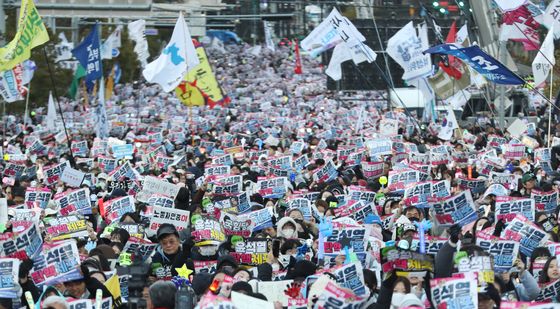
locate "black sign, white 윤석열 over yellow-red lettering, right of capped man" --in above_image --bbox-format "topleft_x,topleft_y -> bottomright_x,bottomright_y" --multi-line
230,238 -> 272,266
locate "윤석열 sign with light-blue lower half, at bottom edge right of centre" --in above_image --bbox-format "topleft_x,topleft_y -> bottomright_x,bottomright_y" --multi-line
430,274 -> 478,309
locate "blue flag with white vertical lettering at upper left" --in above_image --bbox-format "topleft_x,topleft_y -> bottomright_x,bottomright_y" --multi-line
72,24 -> 103,89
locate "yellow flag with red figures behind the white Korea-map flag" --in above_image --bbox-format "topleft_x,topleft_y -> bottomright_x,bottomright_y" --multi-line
175,40 -> 227,108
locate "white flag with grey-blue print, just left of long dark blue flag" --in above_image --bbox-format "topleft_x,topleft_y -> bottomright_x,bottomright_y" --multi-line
386,22 -> 432,80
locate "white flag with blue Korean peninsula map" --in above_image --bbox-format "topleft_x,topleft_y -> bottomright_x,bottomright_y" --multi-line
142,13 -> 199,92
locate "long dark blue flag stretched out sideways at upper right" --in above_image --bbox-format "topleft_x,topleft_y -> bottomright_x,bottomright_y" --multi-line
424,44 -> 525,85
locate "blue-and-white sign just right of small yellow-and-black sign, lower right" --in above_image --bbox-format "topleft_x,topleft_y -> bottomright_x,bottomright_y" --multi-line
476,236 -> 519,272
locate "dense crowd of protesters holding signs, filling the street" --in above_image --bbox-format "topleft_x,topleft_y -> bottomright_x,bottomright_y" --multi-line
0,40 -> 560,308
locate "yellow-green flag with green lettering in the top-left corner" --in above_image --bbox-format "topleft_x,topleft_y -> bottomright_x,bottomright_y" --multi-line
0,0 -> 49,71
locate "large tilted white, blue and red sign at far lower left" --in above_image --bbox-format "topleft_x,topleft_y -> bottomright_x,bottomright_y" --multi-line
30,240 -> 82,286
